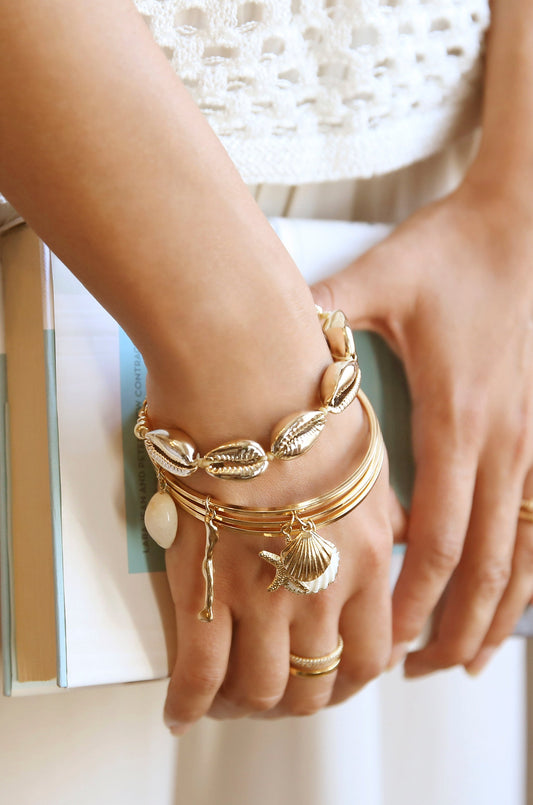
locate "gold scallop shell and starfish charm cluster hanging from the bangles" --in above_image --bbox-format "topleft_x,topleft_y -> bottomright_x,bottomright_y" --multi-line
259,518 -> 339,593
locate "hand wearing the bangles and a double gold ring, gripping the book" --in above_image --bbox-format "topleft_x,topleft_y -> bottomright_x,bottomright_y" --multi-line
145,374 -> 392,735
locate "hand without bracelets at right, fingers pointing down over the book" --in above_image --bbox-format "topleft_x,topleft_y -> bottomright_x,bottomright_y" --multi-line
314,181 -> 533,676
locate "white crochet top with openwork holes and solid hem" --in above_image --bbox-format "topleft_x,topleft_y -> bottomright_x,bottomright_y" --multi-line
135,0 -> 489,184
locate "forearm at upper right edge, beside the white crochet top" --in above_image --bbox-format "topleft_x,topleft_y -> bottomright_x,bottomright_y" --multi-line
470,0 -> 533,211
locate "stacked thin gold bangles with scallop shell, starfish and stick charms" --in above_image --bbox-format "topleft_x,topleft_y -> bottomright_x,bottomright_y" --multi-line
146,391 -> 385,621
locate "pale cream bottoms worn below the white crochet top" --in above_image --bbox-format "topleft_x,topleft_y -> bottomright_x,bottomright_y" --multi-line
0,138 -> 526,805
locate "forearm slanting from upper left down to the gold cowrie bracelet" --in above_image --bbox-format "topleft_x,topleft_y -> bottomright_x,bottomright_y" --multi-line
0,0 -> 328,446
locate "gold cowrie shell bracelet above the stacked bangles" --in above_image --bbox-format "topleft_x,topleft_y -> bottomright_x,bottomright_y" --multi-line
135,306 -> 361,480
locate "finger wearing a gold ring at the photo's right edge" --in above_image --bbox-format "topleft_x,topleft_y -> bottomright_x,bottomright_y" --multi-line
466,474 -> 533,675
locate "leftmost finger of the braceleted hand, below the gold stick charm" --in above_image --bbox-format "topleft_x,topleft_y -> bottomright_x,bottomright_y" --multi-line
165,604 -> 232,735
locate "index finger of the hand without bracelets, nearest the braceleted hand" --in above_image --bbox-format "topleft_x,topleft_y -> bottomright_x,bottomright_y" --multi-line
391,428 -> 476,666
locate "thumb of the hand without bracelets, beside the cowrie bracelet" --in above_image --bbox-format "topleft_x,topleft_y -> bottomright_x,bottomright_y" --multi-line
311,238 -> 401,334
